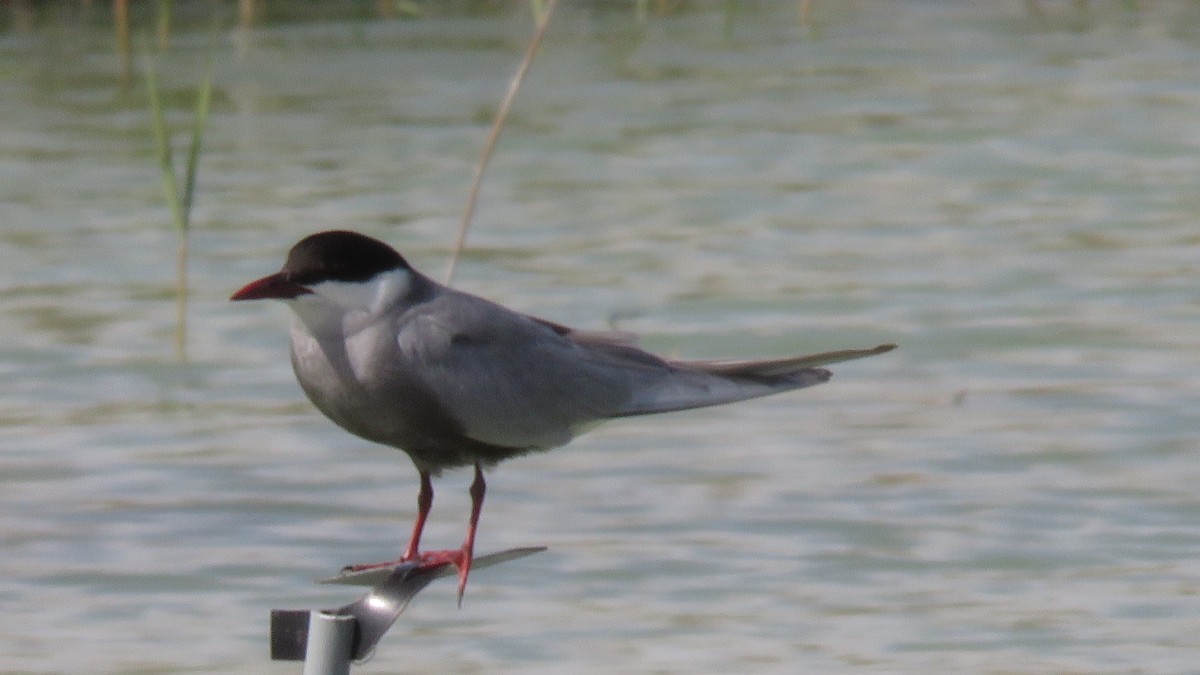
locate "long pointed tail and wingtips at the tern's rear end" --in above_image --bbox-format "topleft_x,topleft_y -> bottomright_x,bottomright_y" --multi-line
613,345 -> 895,417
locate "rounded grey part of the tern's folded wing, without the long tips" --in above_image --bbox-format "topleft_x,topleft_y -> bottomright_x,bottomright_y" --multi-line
397,291 -> 652,448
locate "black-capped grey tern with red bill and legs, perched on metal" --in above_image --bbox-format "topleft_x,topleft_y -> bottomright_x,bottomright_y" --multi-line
230,229 -> 895,607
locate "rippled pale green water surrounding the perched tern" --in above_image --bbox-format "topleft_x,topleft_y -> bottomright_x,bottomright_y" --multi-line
0,0 -> 1200,673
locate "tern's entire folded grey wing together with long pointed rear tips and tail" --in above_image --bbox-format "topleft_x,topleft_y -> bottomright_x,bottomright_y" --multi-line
397,289 -> 893,448
